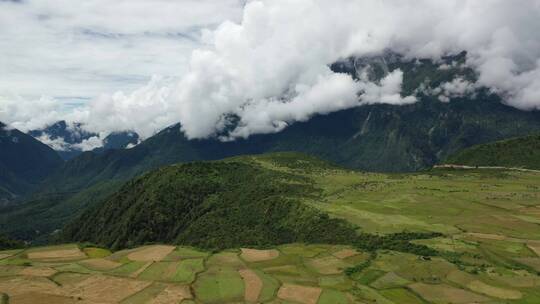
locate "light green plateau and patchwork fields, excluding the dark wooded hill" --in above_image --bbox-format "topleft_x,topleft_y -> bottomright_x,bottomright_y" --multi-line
4,155 -> 540,304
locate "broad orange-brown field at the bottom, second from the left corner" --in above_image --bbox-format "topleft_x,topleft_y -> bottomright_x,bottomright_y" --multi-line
68,275 -> 152,303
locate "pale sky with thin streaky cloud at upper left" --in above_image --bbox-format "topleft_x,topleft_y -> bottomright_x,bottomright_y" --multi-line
0,0 -> 243,106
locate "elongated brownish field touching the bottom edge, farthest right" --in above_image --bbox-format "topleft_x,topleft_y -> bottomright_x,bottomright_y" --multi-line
409,283 -> 489,304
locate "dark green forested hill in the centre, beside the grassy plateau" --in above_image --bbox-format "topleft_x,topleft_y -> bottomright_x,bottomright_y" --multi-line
63,154 -> 355,249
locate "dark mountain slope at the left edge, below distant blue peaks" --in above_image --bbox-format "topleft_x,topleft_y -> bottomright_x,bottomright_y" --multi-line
0,122 -> 63,203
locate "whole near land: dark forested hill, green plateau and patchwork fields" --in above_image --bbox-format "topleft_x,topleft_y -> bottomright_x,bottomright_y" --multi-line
0,153 -> 540,304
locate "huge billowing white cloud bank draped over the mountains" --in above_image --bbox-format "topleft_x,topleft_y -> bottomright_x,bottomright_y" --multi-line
0,0 -> 540,140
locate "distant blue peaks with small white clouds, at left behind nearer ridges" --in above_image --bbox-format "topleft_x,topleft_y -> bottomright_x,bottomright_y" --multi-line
28,120 -> 139,160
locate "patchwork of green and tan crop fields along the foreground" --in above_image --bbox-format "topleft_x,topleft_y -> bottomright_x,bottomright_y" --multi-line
0,241 -> 540,304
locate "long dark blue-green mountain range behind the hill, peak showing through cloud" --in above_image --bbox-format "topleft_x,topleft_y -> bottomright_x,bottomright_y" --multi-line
0,54 -> 540,239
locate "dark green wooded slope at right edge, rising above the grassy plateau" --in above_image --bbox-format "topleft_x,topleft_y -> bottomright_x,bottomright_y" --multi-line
445,135 -> 540,170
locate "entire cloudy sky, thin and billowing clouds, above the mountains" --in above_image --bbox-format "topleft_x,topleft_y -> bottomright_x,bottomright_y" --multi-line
0,0 -> 540,147
